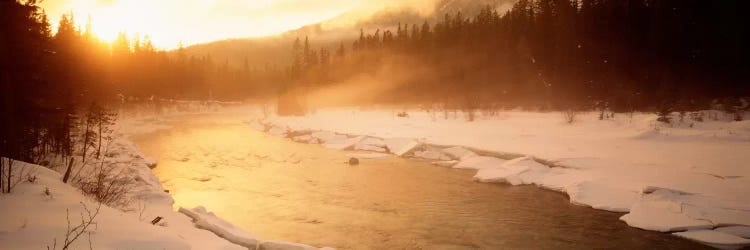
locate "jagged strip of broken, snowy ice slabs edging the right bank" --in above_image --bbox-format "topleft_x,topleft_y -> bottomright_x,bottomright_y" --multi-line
256,111 -> 750,249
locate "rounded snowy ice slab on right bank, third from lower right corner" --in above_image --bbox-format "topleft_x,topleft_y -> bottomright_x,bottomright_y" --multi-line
566,181 -> 640,212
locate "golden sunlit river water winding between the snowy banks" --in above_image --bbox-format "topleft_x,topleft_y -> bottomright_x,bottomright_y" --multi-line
134,114 -> 708,249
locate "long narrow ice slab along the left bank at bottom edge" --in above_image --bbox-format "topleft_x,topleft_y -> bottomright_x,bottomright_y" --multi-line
178,206 -> 258,249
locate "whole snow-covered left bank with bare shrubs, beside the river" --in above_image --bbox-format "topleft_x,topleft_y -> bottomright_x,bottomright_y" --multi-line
0,105 -> 334,250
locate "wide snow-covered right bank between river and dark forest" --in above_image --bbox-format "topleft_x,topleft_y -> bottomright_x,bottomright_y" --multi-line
262,109 -> 750,248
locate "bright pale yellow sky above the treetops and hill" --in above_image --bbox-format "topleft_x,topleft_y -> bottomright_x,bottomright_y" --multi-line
41,0 -> 433,49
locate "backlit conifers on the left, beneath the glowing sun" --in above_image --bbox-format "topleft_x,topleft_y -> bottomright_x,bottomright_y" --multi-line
0,0 -> 284,189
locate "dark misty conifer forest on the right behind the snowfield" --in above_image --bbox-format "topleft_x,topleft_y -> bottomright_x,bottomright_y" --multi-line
286,0 -> 750,111
